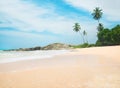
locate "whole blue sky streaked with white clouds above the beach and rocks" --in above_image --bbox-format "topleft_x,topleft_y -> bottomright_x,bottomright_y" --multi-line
0,0 -> 120,49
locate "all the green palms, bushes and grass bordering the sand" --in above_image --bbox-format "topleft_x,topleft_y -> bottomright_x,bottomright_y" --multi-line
72,7 -> 120,48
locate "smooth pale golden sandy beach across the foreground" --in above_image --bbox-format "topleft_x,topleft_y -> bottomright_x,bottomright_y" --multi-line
0,46 -> 120,88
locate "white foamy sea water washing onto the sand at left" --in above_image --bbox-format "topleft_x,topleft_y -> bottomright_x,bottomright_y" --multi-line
0,50 -> 68,63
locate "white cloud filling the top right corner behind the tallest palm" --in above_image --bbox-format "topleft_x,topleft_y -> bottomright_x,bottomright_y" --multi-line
65,0 -> 120,21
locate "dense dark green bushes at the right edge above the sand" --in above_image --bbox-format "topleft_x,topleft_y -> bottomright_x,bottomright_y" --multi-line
96,25 -> 120,46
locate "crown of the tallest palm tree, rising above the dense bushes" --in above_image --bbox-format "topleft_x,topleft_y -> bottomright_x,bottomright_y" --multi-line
92,7 -> 103,24
